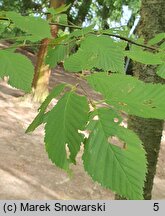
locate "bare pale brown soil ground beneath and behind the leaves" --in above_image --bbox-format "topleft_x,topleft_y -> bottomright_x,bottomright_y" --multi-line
0,61 -> 165,200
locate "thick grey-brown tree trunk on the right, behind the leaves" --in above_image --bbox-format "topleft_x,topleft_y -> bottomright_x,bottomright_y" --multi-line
117,0 -> 165,200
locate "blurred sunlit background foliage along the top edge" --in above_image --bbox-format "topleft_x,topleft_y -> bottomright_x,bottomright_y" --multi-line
0,0 -> 140,28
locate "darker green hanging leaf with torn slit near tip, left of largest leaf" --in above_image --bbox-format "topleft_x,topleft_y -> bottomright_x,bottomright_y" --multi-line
45,92 -> 89,170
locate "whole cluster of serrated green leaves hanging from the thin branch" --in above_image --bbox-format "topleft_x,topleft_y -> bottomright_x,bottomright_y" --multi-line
0,8 -> 165,199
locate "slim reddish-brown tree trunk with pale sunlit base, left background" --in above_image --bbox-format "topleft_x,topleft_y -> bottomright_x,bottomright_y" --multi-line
32,0 -> 64,102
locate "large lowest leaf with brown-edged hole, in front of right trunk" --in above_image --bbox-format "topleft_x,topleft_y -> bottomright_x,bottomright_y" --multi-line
83,108 -> 147,200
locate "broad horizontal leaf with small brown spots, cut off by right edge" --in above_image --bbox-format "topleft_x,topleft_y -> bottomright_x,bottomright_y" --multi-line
88,73 -> 165,119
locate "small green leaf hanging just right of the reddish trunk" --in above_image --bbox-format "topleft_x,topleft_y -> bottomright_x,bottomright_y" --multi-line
45,44 -> 69,68
